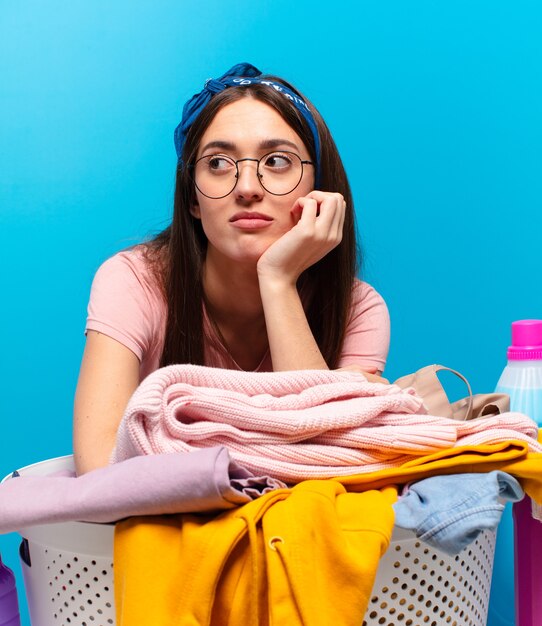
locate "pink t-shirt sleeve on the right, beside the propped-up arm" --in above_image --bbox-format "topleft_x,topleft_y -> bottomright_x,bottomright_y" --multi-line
339,281 -> 390,372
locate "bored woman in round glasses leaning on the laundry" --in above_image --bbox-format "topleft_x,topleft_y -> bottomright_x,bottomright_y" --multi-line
74,64 -> 389,473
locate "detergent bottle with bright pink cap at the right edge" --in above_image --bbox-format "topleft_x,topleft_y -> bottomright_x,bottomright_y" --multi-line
497,320 -> 542,626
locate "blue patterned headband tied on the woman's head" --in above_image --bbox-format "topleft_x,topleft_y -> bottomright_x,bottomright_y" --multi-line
173,63 -> 320,188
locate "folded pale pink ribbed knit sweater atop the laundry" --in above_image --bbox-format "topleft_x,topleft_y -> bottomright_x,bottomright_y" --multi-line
111,365 -> 542,482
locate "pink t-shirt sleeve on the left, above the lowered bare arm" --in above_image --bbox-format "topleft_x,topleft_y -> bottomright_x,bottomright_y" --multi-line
85,251 -> 164,362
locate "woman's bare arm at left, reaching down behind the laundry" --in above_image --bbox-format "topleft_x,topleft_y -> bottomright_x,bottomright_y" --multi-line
73,330 -> 139,474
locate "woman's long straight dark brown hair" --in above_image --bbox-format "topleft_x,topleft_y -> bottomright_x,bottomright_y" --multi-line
146,76 -> 359,369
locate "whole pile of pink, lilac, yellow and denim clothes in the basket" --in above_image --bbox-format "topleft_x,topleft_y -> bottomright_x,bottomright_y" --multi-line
0,365 -> 542,626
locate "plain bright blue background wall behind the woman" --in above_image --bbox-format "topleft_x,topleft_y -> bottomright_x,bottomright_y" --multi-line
0,0 -> 542,626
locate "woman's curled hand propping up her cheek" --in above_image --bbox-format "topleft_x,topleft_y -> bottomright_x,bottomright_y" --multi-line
258,191 -> 346,285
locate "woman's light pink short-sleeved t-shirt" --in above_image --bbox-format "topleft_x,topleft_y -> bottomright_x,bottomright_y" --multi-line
86,248 -> 390,380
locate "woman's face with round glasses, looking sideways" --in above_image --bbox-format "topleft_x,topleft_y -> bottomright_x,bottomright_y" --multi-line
191,97 -> 314,264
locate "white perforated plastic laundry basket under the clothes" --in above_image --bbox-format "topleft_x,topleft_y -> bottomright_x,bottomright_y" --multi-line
6,456 -> 495,626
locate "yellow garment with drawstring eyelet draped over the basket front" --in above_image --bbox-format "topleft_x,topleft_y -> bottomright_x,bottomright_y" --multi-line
114,480 -> 397,626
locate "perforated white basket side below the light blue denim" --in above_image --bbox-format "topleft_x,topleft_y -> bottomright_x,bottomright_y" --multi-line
363,531 -> 495,626
